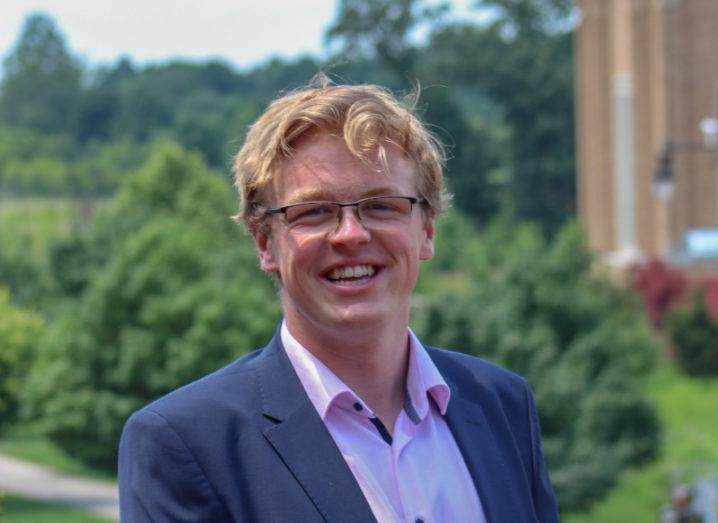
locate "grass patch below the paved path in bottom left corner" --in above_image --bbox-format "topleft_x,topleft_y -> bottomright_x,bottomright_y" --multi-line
0,494 -> 112,523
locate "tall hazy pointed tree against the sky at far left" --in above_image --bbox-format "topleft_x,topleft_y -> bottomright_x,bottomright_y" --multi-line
0,13 -> 82,133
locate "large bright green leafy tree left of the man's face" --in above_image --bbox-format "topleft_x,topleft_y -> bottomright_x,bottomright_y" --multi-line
26,146 -> 279,470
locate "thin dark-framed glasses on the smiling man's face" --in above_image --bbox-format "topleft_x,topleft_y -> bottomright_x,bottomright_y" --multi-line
264,196 -> 426,231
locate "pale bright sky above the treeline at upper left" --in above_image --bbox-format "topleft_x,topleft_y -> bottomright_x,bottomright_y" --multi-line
0,0 -> 490,73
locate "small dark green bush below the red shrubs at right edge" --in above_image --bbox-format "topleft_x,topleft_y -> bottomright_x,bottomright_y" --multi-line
666,289 -> 718,376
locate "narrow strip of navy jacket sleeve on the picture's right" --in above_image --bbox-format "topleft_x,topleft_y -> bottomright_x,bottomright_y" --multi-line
526,383 -> 559,523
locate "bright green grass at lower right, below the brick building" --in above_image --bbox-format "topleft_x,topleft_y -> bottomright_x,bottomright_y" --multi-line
562,365 -> 718,523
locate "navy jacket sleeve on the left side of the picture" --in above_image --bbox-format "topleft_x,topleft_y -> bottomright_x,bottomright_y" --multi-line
118,409 -> 229,523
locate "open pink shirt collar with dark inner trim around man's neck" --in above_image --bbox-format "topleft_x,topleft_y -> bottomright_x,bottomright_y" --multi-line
280,321 -> 451,423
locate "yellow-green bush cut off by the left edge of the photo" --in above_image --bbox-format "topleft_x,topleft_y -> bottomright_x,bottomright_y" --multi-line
0,287 -> 44,430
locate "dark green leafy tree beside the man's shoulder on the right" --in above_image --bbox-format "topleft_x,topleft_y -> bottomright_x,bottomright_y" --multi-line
415,219 -> 659,512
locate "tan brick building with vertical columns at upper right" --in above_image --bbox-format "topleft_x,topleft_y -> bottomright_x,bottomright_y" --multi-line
575,0 -> 718,267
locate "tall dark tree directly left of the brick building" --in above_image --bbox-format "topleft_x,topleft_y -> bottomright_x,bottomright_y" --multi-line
422,0 -> 575,232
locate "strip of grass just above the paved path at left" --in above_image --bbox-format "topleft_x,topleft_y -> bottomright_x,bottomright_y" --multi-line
0,430 -> 116,481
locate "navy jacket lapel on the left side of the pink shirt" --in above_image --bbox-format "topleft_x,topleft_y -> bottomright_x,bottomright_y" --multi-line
258,333 -> 376,523
